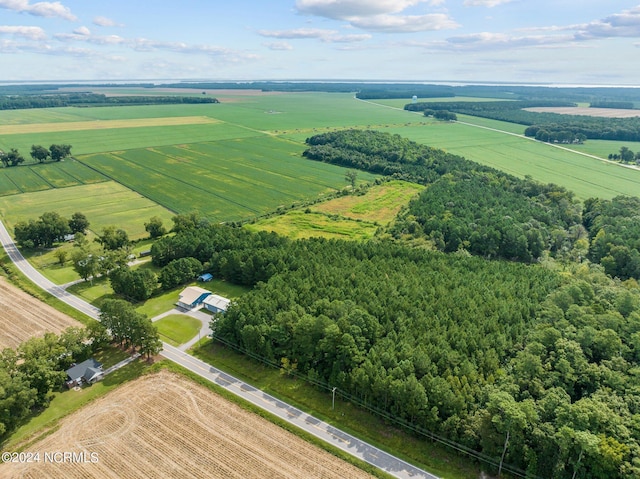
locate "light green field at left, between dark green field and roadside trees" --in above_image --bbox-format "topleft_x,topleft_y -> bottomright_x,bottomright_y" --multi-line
0,181 -> 174,239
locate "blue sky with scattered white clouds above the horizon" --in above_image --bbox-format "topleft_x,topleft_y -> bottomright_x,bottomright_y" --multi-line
0,0 -> 640,86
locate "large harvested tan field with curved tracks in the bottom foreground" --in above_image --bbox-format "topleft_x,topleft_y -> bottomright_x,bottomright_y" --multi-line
0,371 -> 378,479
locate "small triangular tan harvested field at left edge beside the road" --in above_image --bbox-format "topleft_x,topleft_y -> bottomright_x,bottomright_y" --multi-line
0,277 -> 82,350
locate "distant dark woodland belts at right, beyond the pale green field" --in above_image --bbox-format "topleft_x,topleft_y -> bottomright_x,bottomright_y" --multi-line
405,101 -> 640,143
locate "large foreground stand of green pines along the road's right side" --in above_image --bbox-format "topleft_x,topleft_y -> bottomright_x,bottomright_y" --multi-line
152,219 -> 640,478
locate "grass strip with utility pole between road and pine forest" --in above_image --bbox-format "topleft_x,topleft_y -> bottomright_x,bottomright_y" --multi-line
190,340 -> 479,479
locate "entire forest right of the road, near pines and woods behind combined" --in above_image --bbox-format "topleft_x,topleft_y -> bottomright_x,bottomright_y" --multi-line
145,125 -> 640,479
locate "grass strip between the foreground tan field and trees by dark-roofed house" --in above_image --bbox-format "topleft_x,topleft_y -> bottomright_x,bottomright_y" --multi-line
2,348 -> 149,451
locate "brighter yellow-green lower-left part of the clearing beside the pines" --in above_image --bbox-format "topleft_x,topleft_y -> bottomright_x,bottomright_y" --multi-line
246,210 -> 378,240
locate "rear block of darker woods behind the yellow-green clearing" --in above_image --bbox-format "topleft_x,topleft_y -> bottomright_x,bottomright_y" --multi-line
304,130 -> 640,280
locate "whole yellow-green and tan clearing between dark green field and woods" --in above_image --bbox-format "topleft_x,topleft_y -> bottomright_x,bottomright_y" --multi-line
245,181 -> 424,240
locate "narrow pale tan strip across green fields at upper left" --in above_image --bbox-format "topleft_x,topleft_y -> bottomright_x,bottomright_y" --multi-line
2,116 -> 220,135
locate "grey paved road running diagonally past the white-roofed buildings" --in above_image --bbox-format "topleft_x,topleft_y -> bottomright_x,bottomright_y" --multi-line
0,222 -> 439,479
